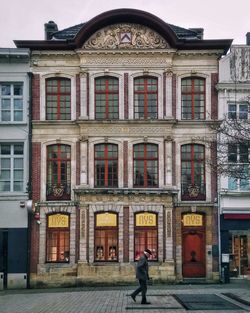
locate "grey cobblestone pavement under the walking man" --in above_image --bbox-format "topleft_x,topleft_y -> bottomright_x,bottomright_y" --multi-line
0,281 -> 250,313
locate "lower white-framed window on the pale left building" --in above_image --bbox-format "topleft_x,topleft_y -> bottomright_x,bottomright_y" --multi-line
0,143 -> 24,192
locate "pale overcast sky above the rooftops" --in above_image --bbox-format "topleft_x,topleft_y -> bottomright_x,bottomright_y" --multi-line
0,0 -> 250,48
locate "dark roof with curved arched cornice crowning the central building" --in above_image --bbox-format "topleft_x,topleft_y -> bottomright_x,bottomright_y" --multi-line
14,9 -> 232,54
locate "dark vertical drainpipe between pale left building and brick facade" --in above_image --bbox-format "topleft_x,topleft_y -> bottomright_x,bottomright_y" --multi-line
27,72 -> 33,288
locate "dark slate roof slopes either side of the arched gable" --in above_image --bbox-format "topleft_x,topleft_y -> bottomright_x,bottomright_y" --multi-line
52,23 -> 200,40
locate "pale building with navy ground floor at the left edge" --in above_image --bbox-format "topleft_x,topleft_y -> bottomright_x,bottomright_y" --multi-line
0,48 -> 30,290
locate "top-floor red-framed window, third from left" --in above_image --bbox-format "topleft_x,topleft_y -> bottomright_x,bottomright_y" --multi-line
134,77 -> 158,119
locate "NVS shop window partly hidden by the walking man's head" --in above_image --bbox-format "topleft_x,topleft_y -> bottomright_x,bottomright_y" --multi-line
134,212 -> 158,261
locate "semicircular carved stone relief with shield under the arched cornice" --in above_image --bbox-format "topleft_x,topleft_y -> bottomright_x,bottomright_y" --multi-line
83,24 -> 169,50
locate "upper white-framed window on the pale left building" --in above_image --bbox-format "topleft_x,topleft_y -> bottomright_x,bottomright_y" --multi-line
0,82 -> 24,122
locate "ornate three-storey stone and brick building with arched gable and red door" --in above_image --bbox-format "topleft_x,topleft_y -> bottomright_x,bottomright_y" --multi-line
15,9 -> 231,286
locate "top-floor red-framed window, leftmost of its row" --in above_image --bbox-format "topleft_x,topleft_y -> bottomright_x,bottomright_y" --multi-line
46,78 -> 71,120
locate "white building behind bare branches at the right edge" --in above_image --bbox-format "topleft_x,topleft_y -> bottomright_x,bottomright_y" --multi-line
218,33 -> 250,278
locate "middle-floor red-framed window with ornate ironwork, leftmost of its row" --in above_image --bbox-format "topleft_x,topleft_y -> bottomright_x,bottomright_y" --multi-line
47,144 -> 71,200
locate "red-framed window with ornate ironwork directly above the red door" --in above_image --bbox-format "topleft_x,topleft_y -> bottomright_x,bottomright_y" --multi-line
181,144 -> 206,201
